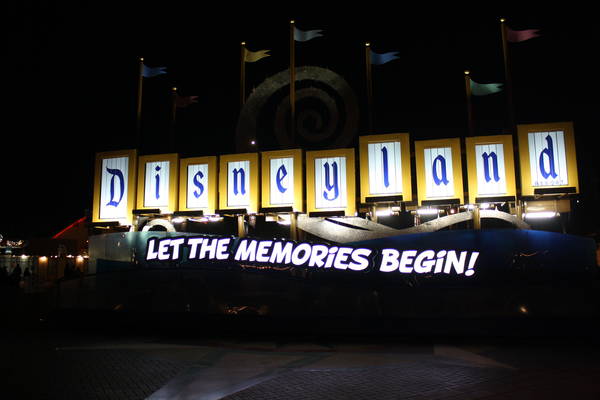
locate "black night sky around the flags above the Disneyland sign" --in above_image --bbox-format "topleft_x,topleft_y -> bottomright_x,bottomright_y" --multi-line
0,2 -> 600,239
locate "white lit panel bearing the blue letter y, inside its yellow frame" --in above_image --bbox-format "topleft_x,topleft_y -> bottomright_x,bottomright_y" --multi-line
315,157 -> 348,208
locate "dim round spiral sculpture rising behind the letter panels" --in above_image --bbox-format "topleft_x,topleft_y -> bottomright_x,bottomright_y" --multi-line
236,66 -> 359,152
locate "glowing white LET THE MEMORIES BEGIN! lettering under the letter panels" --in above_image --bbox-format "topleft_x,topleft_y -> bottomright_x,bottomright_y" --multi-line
146,235 -> 479,276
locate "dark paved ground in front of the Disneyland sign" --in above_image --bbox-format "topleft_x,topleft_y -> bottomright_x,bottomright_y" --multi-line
0,310 -> 600,400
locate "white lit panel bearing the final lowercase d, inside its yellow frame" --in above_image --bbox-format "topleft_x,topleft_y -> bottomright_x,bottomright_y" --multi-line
527,131 -> 569,187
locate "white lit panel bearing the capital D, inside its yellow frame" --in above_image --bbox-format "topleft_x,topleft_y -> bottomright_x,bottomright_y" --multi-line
100,157 -> 129,219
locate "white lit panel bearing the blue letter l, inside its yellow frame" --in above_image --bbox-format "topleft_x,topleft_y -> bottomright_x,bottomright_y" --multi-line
368,142 -> 402,194
